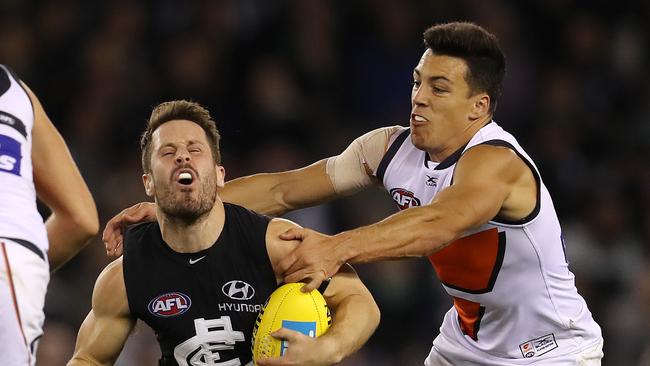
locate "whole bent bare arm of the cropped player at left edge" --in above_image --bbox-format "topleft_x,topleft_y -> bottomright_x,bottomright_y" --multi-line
23,84 -> 99,271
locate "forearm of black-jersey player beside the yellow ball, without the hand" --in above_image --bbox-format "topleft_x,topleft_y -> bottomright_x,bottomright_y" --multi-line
319,293 -> 380,363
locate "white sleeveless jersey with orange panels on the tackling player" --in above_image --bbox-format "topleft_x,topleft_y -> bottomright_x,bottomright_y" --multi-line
377,121 -> 601,365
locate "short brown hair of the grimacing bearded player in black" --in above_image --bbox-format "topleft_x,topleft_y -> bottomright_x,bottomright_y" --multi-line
140,100 -> 221,173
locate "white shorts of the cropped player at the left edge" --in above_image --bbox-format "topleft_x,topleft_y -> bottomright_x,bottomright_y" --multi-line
0,239 -> 50,366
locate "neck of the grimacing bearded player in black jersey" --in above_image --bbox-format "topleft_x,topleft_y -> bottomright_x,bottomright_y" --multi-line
158,196 -> 225,253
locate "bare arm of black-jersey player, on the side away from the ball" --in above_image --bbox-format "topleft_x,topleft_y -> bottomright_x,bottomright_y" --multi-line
68,258 -> 135,366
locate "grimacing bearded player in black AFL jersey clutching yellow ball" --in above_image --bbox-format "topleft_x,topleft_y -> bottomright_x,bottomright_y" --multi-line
68,101 -> 379,366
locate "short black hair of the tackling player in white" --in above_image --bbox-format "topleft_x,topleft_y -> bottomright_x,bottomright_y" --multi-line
424,22 -> 506,113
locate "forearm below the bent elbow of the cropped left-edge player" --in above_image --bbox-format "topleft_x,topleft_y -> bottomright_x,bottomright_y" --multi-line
45,213 -> 99,271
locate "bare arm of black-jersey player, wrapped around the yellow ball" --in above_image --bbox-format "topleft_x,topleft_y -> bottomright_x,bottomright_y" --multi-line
257,219 -> 380,366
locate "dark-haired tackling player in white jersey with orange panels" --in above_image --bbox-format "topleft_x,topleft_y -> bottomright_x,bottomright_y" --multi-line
104,23 -> 603,366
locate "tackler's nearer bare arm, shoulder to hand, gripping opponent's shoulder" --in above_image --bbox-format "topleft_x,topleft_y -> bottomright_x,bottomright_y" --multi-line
280,146 -> 536,290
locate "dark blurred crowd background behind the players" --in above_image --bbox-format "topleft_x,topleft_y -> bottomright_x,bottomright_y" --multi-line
0,0 -> 650,366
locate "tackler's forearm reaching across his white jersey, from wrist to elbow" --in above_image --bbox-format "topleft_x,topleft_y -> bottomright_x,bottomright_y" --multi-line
336,206 -> 467,263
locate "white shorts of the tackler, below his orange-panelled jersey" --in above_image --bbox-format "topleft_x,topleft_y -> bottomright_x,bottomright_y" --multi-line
424,336 -> 603,366
